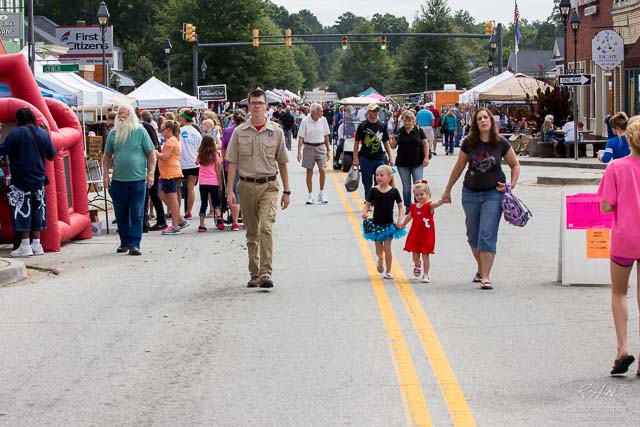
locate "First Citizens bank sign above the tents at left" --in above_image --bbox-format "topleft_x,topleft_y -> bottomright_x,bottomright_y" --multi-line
56,25 -> 113,65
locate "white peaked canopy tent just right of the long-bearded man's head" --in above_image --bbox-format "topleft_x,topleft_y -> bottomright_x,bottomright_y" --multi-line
129,77 -> 207,110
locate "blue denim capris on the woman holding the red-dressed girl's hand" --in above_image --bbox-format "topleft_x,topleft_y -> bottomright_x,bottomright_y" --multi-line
462,188 -> 504,254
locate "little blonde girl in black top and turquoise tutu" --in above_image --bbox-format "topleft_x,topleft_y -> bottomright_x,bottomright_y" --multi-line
362,165 -> 407,279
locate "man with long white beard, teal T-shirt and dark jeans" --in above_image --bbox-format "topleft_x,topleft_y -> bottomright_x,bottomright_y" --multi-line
102,105 -> 156,255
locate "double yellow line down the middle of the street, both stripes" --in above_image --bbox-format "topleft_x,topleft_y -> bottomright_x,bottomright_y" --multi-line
330,170 -> 476,427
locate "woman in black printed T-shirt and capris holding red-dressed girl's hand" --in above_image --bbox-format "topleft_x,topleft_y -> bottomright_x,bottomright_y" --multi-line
442,108 -> 520,289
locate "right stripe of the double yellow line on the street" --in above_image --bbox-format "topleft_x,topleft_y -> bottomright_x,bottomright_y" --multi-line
336,173 -> 476,427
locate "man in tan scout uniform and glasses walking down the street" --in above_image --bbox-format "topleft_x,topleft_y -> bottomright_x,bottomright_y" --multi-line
226,89 -> 291,288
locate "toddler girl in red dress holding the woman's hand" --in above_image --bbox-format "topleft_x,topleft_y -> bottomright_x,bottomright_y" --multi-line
402,180 -> 444,283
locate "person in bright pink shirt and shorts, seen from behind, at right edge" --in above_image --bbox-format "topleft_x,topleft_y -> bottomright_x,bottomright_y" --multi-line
598,116 -> 640,376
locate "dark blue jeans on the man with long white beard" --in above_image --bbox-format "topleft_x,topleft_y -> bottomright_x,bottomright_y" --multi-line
111,180 -> 147,248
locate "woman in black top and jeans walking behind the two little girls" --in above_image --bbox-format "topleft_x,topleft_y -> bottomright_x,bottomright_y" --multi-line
391,111 -> 429,212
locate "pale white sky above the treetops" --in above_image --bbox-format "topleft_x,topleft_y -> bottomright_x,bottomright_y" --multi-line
271,0 -> 553,26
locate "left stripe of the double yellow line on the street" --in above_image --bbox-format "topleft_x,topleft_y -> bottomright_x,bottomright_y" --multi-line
330,170 -> 433,427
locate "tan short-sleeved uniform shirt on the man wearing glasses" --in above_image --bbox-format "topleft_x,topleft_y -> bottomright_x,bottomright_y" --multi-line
226,120 -> 289,178
